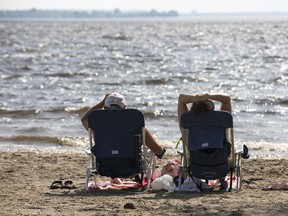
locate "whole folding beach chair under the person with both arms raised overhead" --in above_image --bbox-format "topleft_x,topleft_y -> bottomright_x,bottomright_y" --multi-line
177,111 -> 249,191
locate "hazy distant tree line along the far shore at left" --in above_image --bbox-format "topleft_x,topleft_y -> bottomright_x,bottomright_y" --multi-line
0,8 -> 179,18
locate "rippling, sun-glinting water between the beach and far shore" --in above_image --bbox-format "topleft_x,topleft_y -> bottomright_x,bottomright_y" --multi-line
0,17 -> 288,157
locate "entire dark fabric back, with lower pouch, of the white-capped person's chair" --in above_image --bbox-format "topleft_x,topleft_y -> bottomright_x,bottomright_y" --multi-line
88,109 -> 145,178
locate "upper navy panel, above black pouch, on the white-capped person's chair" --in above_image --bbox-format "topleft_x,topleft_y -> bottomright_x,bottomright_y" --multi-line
88,109 -> 145,158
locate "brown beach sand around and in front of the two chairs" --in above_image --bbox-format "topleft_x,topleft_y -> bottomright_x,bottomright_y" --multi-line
0,152 -> 288,216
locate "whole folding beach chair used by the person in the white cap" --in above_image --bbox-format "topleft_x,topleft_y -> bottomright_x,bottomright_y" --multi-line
85,109 -> 155,193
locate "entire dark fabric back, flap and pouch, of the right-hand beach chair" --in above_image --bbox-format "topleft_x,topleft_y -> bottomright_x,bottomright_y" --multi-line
181,111 -> 233,180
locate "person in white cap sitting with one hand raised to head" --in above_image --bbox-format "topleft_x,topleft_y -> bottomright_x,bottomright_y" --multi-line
81,92 -> 166,183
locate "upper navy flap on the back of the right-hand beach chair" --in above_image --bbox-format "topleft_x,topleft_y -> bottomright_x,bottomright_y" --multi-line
181,111 -> 233,151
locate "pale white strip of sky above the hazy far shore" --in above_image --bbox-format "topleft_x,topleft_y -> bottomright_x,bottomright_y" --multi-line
0,0 -> 288,13
